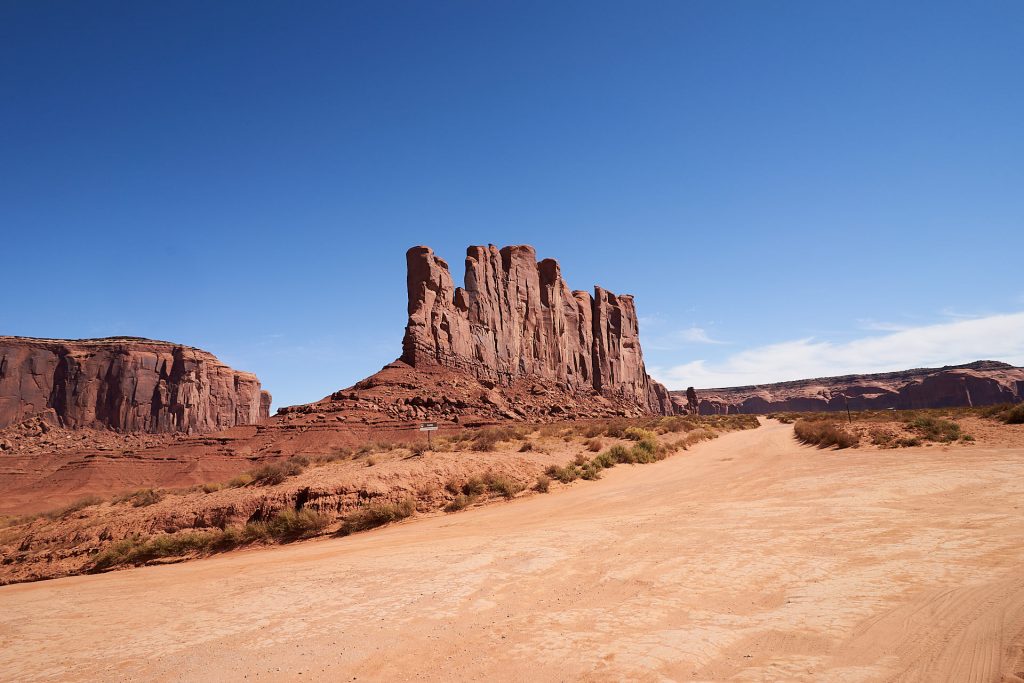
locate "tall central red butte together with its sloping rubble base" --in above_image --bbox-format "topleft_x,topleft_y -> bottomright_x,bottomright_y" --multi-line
280,245 -> 676,426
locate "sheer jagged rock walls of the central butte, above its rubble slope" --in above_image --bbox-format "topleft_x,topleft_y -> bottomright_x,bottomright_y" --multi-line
401,245 -> 673,414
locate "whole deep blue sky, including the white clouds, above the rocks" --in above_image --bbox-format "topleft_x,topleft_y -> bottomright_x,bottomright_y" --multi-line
0,0 -> 1024,405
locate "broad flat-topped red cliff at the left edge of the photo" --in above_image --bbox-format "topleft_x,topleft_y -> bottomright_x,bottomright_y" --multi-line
0,337 -> 270,433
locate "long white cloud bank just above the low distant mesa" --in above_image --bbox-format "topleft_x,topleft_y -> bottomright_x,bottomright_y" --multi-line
651,312 -> 1024,389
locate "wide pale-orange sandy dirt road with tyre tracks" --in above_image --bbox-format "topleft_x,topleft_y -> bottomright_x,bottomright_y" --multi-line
0,423 -> 1024,682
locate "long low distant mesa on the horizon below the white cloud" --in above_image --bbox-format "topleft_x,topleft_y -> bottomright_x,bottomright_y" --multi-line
673,360 -> 1024,415
